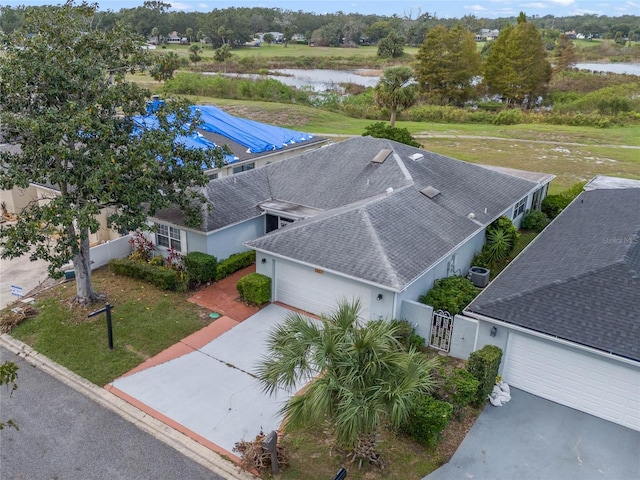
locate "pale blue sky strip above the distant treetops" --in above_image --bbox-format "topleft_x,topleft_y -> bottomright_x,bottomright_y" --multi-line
2,0 -> 640,18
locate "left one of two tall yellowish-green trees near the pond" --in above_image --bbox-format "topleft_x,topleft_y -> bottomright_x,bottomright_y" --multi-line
415,24 -> 482,106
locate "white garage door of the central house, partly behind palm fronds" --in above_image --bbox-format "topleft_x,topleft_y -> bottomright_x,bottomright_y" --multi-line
275,261 -> 371,320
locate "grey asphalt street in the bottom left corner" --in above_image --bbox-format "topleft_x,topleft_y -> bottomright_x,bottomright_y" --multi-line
0,348 -> 229,480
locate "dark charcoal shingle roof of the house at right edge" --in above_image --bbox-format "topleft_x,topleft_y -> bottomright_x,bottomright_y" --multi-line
467,177 -> 640,361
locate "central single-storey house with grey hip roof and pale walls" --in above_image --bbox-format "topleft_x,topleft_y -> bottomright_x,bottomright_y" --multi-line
150,137 -> 553,323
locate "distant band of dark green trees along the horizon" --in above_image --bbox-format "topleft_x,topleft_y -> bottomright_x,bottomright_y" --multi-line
0,0 -> 640,48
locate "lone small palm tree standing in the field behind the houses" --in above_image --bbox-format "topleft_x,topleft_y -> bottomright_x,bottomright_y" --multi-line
373,66 -> 416,127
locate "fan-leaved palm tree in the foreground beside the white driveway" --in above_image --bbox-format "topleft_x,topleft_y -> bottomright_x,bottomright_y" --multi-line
257,301 -> 435,463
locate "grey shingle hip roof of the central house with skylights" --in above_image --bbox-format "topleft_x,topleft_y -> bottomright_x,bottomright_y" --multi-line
156,137 -> 539,290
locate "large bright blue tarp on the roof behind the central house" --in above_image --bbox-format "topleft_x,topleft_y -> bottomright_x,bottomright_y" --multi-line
191,105 -> 314,153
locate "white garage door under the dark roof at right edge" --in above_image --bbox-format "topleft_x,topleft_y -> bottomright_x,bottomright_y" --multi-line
503,333 -> 640,430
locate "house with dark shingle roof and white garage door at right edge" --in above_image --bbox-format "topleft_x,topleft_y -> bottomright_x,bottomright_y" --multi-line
450,177 -> 640,430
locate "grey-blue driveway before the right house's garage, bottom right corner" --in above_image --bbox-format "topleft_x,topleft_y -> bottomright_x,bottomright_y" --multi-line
425,388 -> 640,480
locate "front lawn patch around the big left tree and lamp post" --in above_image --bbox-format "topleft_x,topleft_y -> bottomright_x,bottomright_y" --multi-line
11,269 -> 208,386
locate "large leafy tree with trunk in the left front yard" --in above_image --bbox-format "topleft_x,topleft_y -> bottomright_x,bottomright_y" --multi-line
0,3 -> 222,303
